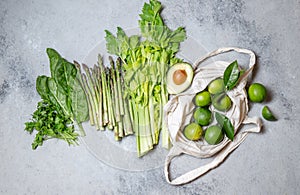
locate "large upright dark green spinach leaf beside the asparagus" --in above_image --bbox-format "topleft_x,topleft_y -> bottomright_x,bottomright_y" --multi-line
47,48 -> 88,123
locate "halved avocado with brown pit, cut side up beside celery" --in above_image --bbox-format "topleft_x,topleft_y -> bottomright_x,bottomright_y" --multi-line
167,62 -> 194,94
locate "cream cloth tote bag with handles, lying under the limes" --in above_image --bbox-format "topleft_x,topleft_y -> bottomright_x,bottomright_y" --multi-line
164,47 -> 262,185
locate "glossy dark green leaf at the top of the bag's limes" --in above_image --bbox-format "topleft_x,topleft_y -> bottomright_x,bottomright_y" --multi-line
223,60 -> 240,90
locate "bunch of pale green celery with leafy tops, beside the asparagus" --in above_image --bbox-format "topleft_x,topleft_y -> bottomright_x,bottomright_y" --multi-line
105,0 -> 186,156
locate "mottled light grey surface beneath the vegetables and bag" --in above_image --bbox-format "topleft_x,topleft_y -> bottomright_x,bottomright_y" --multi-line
0,0 -> 300,194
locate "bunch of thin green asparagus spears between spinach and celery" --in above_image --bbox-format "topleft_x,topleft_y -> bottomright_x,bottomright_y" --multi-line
74,55 -> 133,140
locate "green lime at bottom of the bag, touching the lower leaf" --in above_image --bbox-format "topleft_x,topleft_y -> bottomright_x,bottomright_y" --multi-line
204,125 -> 224,145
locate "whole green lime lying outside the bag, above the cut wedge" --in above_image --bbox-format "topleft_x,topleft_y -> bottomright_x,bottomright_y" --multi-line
248,83 -> 267,102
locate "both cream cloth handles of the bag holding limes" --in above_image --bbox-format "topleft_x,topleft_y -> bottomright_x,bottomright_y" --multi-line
164,47 -> 262,185
